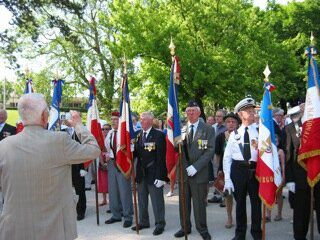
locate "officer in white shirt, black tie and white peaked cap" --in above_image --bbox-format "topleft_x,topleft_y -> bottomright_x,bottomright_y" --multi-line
223,98 -> 262,240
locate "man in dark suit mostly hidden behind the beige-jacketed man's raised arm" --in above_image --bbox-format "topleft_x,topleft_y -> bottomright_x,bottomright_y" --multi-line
61,125 -> 87,221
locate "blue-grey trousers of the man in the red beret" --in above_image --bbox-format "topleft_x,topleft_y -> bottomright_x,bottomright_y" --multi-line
107,159 -> 133,221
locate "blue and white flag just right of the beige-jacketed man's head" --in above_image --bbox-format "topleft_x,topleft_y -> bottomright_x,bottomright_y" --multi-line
48,79 -> 64,131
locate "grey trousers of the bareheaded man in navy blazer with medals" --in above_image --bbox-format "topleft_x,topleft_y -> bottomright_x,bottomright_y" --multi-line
137,178 -> 166,228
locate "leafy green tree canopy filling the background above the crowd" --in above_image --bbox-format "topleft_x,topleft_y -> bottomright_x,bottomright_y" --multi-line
0,0 -> 320,118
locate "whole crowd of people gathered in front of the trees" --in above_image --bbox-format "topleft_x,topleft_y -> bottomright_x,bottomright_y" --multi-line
0,93 -> 320,240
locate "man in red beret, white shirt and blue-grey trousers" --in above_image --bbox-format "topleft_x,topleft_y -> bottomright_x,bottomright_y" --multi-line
105,112 -> 133,228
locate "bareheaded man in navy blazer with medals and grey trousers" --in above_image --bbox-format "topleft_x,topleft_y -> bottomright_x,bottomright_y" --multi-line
132,112 -> 167,235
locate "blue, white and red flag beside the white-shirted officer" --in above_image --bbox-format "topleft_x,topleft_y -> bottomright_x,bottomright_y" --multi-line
256,82 -> 282,208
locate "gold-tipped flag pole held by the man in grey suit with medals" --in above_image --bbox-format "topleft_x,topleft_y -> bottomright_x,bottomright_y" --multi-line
169,37 -> 188,240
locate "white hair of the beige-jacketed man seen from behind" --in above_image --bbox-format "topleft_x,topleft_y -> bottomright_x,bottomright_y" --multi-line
18,93 -> 48,126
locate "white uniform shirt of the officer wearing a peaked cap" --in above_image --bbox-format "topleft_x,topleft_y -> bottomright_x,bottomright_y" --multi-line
223,124 -> 258,179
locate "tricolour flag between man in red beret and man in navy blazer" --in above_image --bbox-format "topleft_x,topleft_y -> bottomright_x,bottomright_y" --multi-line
116,73 -> 134,178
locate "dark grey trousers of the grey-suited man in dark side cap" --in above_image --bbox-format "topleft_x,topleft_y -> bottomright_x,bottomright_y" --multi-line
179,180 -> 208,234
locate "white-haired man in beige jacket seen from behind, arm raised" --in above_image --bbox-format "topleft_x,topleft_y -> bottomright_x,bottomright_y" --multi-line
0,93 -> 100,240
